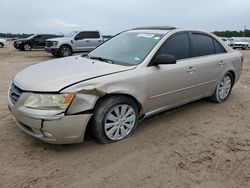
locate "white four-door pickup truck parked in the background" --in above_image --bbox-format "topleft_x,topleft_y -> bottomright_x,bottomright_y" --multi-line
45,31 -> 103,57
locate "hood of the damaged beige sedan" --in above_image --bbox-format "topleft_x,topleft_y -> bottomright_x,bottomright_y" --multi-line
13,56 -> 136,92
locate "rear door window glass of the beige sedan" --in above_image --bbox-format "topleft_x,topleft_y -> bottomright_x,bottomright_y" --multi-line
192,33 -> 214,57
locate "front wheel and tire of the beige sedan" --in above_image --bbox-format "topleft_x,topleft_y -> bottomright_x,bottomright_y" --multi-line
92,96 -> 138,144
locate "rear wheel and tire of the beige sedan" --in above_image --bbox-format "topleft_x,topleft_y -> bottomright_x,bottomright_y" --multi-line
211,72 -> 234,103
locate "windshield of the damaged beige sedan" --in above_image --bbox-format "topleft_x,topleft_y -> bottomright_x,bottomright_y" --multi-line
88,32 -> 164,65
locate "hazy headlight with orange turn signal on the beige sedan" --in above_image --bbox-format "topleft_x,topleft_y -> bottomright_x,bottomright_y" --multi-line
24,93 -> 74,110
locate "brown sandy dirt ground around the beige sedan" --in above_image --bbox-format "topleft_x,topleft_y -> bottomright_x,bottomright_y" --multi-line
0,42 -> 250,188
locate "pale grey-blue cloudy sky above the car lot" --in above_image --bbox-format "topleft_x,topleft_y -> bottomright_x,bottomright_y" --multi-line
0,0 -> 250,35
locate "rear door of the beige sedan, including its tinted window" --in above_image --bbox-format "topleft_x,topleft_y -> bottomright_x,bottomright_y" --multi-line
189,32 -> 229,97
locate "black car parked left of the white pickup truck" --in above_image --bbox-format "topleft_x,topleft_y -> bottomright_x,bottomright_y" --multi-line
13,34 -> 62,51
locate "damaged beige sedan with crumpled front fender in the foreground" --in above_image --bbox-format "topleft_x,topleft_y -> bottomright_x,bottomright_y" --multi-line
8,27 -> 243,144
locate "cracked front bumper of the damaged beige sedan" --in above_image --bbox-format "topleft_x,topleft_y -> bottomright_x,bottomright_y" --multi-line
9,95 -> 92,144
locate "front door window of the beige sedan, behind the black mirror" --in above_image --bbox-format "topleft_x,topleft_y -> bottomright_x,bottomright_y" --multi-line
158,33 -> 190,60
